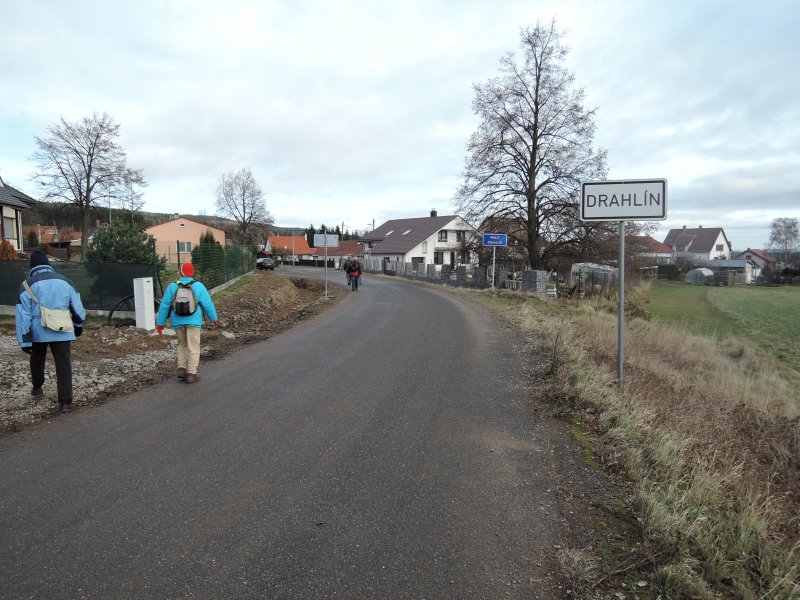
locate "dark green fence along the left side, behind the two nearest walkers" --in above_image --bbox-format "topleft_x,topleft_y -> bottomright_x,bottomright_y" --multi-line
0,244 -> 255,311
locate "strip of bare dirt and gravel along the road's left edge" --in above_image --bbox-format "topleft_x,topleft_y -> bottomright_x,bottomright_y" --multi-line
0,271 -> 347,434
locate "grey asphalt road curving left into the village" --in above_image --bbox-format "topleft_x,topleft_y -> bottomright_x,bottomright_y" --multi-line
0,268 -> 560,599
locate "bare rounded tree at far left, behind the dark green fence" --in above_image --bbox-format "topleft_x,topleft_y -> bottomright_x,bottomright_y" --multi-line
33,113 -> 146,257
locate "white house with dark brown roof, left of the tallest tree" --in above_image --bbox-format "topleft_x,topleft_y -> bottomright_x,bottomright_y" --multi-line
358,210 -> 476,269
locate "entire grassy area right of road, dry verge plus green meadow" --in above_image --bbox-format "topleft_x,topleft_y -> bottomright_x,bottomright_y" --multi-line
479,283 -> 800,600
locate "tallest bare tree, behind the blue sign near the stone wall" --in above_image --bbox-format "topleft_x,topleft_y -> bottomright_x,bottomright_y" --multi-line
456,21 -> 606,268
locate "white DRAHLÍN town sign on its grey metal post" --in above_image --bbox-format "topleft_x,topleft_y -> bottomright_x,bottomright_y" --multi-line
581,179 -> 667,391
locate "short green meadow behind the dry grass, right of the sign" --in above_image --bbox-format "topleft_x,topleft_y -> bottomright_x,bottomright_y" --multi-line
646,282 -> 800,391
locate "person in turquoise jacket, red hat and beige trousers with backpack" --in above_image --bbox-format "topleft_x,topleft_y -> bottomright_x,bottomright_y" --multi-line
156,263 -> 219,383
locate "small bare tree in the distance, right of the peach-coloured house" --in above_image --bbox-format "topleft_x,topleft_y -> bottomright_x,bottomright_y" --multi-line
217,168 -> 274,243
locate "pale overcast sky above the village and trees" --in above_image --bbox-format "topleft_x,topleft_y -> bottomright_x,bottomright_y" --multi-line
0,0 -> 800,249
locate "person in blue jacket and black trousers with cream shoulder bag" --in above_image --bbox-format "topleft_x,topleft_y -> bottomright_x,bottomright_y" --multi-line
15,250 -> 86,412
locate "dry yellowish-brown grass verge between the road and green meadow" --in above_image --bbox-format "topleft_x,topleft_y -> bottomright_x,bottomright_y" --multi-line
488,288 -> 800,599
